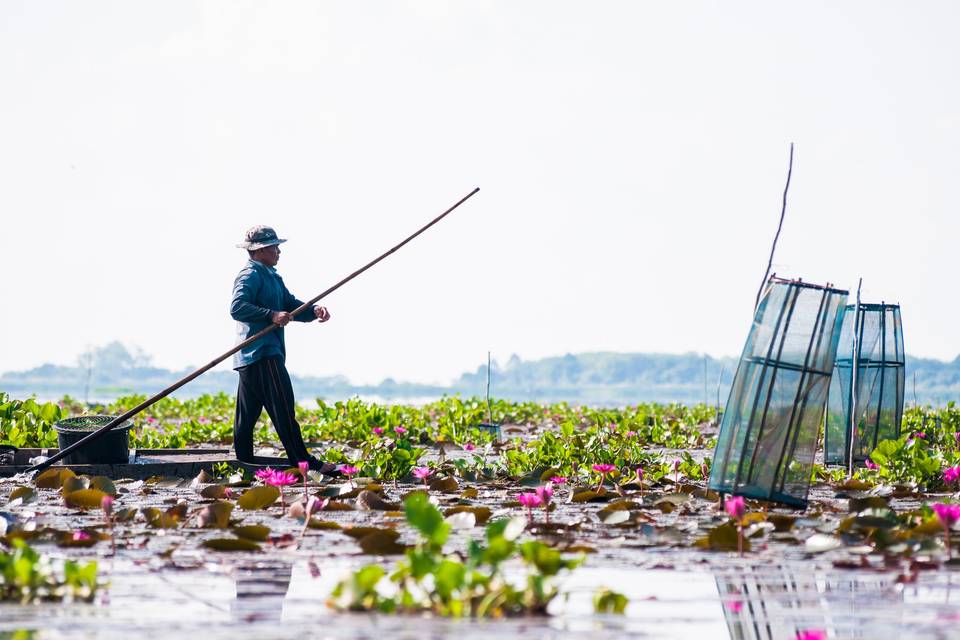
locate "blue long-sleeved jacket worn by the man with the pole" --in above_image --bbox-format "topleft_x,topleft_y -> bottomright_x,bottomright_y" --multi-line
230,260 -> 316,369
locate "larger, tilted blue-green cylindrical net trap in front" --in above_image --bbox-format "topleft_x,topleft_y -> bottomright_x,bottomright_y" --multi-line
710,278 -> 847,507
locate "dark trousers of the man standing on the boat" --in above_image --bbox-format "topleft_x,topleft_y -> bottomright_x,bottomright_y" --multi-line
233,356 -> 308,464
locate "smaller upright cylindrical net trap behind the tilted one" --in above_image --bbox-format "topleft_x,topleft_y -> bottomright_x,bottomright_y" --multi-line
823,304 -> 906,465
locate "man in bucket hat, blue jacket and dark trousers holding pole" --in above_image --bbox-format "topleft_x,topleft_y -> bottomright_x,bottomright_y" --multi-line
230,225 -> 335,475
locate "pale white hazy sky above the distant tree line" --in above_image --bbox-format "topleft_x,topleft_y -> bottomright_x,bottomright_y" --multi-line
0,0 -> 960,382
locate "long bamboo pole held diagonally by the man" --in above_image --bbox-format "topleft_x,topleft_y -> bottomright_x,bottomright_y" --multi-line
27,187 -> 480,471
